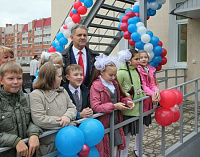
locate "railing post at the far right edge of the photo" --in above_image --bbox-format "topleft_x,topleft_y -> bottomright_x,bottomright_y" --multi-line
194,80 -> 198,133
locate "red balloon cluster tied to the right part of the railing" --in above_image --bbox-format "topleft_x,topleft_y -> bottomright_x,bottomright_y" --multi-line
155,89 -> 183,126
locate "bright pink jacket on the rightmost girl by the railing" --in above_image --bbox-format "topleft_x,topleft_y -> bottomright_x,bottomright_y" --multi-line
137,65 -> 158,112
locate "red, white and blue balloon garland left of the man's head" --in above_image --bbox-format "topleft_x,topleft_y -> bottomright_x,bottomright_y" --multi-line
48,0 -> 93,52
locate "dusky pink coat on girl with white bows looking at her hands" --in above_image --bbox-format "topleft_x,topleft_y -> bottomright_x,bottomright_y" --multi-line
90,79 -> 132,157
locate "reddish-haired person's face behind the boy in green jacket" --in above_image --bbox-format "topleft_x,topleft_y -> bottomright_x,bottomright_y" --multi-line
0,46 -> 15,66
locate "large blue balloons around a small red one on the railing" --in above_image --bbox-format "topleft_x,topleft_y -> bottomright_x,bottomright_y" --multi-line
55,119 -> 104,157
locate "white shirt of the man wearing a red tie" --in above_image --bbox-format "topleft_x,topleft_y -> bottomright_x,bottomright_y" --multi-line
72,45 -> 87,76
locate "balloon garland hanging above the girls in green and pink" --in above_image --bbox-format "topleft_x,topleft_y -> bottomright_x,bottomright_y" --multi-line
118,0 -> 167,71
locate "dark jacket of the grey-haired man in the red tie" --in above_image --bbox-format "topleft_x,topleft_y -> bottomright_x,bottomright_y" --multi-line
61,45 -> 99,87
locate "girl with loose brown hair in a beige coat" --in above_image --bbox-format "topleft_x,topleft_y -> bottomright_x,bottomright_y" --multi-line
30,62 -> 77,157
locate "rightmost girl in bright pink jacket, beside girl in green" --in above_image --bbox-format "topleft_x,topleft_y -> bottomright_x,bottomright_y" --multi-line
137,50 -> 160,111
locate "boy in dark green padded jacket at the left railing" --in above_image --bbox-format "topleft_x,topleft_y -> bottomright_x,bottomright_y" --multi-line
0,62 -> 42,156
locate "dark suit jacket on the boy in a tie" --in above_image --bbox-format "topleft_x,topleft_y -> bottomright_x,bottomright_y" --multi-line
62,83 -> 90,119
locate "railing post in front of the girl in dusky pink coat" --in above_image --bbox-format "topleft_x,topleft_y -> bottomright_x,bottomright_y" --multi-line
110,111 -> 115,157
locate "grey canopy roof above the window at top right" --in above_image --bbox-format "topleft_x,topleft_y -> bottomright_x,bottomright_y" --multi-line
170,0 -> 200,19
